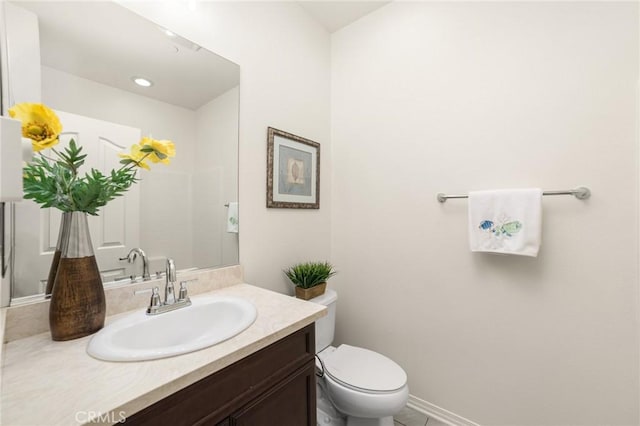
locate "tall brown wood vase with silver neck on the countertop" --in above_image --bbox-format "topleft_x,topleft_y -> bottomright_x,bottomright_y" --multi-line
49,212 -> 107,340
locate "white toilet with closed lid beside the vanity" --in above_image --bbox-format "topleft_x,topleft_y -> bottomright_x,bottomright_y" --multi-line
310,290 -> 409,426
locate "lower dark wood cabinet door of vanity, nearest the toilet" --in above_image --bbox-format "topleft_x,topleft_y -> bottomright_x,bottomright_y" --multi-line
230,362 -> 316,426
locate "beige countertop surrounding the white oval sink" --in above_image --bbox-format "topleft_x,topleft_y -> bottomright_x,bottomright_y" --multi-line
0,284 -> 326,426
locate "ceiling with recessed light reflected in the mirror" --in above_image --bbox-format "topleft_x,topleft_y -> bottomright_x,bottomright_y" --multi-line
15,1 -> 239,110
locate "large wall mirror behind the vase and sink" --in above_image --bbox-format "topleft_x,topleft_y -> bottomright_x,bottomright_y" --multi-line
5,1 -> 240,303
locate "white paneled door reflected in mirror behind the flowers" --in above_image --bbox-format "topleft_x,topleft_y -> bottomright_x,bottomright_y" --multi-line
15,111 -> 141,296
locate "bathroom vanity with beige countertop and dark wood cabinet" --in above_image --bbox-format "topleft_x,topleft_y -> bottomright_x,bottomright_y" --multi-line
0,271 -> 326,426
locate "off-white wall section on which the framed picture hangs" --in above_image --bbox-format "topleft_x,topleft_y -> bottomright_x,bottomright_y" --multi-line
125,2 -> 331,293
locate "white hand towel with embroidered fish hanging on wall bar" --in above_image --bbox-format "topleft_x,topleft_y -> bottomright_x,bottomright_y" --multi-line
469,188 -> 542,257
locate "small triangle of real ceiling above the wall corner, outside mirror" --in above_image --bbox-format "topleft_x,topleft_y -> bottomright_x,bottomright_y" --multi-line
298,0 -> 391,33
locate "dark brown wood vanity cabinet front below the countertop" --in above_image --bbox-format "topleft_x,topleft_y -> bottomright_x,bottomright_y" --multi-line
126,324 -> 316,426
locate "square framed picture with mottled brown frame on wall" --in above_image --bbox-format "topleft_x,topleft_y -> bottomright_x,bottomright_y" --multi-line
267,127 -> 320,209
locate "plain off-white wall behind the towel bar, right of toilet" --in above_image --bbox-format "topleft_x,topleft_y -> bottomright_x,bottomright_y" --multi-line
331,2 -> 640,425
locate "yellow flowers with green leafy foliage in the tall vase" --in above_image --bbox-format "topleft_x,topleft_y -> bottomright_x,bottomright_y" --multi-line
9,103 -> 175,216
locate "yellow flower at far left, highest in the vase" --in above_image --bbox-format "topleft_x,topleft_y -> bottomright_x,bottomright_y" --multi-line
9,102 -> 62,152
